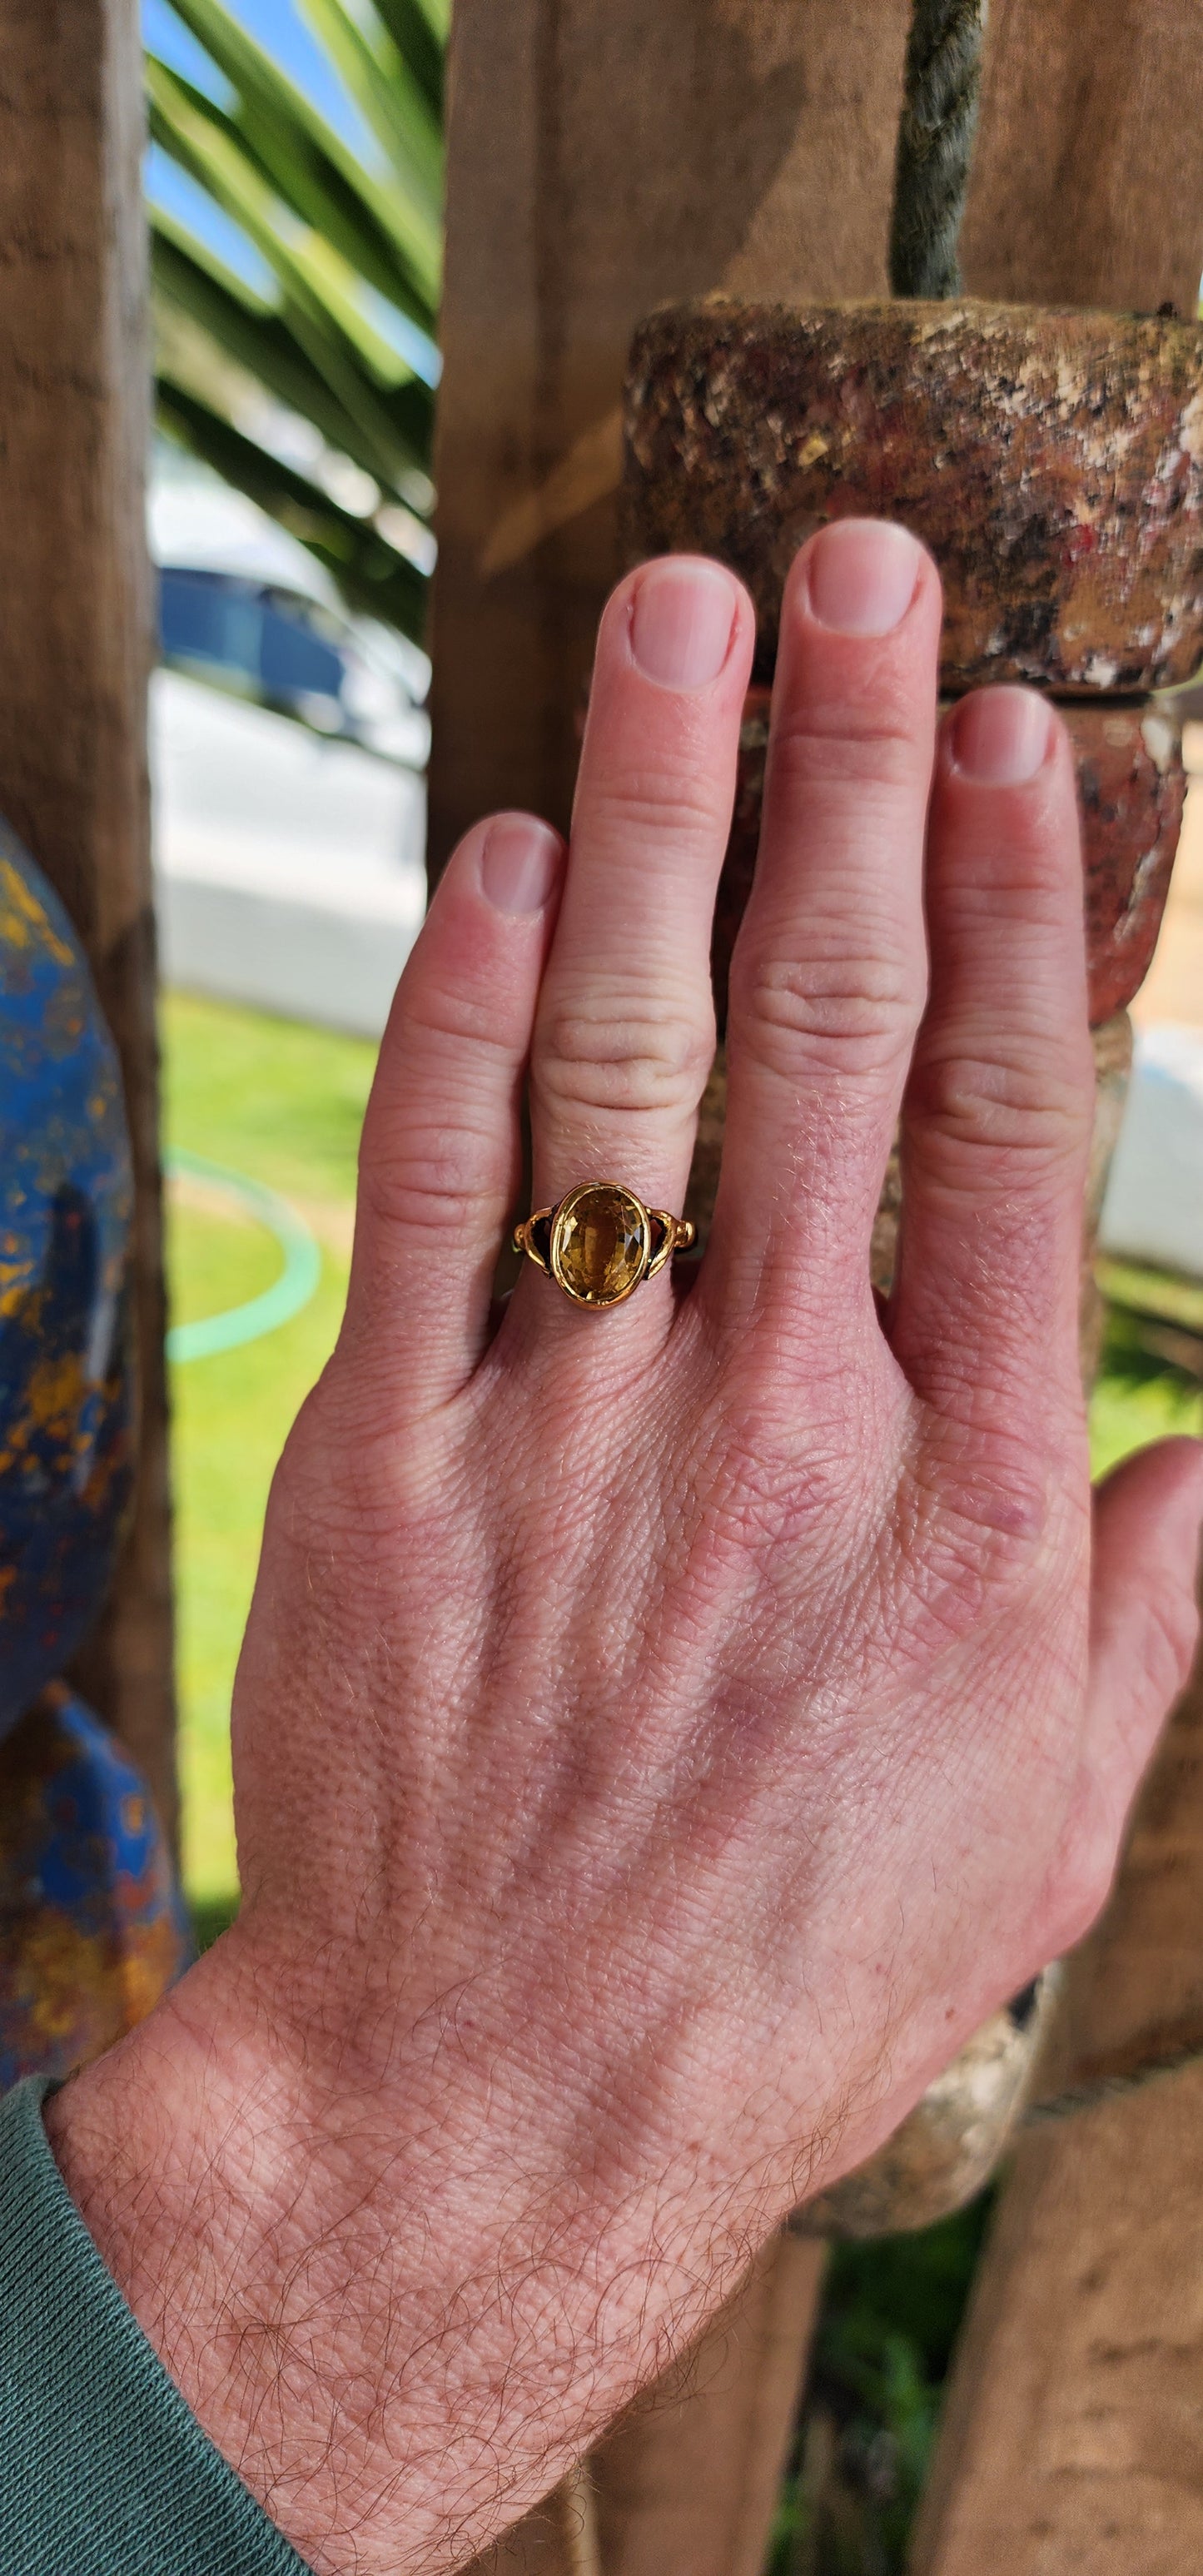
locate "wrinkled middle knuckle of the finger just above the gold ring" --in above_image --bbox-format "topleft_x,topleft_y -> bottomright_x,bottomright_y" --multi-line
530,994 -> 713,1113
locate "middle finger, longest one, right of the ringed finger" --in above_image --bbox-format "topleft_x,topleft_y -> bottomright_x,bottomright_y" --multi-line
703,520 -> 940,1342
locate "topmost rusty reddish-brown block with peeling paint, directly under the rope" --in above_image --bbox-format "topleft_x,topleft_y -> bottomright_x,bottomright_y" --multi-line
626,296 -> 1203,695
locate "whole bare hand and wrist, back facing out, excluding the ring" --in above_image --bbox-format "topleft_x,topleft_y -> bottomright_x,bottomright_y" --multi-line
49,523 -> 1203,2576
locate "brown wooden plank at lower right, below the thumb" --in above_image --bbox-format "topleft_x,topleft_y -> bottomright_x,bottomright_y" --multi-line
912,1566 -> 1203,2576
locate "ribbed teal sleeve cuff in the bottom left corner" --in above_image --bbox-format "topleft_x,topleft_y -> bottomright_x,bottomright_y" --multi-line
0,2079 -> 306,2576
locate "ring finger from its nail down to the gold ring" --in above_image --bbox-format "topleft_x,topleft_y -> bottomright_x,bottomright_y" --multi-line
520,556 -> 753,1311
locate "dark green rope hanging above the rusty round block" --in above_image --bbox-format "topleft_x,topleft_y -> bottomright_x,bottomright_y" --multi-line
889,0 -> 987,296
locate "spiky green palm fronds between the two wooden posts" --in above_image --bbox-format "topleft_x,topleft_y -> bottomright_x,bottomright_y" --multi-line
147,0 -> 448,641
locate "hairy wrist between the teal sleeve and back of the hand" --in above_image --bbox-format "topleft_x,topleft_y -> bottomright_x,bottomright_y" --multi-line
47,1942 -> 773,2576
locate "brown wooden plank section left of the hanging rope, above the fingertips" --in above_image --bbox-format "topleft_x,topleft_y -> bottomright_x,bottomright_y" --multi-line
430,0 -> 909,871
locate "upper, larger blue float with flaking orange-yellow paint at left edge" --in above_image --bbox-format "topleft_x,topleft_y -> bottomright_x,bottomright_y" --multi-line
0,822 -> 134,1733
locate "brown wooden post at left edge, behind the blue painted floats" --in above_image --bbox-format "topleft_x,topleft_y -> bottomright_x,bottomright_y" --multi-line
0,0 -> 175,1827
